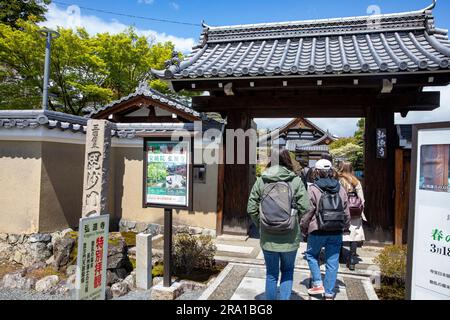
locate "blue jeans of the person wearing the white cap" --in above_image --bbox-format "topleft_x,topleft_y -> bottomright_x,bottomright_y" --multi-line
306,234 -> 342,297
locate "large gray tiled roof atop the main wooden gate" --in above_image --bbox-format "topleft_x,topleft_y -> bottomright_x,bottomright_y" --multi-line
152,3 -> 450,80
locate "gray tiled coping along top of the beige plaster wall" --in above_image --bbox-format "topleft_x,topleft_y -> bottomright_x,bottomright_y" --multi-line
0,110 -> 221,139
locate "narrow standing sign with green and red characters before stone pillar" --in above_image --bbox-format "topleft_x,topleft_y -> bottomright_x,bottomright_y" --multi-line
75,214 -> 109,300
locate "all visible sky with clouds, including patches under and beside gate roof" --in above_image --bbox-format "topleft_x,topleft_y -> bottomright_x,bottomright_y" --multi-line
44,0 -> 450,136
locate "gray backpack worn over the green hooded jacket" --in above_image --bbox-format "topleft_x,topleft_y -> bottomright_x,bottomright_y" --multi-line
260,181 -> 297,234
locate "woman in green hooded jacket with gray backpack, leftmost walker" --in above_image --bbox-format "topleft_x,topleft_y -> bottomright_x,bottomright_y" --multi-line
247,149 -> 309,300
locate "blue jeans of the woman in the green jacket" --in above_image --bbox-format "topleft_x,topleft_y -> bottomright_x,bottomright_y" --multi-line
263,250 -> 297,300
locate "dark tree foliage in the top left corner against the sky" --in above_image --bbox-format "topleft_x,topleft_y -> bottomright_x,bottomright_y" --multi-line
0,0 -> 51,28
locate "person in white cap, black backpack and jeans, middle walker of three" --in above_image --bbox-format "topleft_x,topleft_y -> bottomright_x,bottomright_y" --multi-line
301,159 -> 350,300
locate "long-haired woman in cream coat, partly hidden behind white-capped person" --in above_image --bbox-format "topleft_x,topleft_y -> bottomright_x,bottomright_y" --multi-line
338,161 -> 367,270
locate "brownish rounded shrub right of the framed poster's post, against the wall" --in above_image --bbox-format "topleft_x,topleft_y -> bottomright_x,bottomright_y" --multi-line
173,233 -> 217,275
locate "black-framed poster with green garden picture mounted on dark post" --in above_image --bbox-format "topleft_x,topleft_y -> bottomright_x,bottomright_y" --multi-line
144,137 -> 193,210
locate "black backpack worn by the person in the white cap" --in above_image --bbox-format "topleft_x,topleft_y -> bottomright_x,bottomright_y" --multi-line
314,185 -> 345,232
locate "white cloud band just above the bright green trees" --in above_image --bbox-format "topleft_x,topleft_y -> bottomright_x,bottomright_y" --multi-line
41,0 -> 195,53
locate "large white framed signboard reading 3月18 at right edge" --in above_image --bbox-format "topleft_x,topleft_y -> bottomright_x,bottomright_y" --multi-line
407,123 -> 450,300
